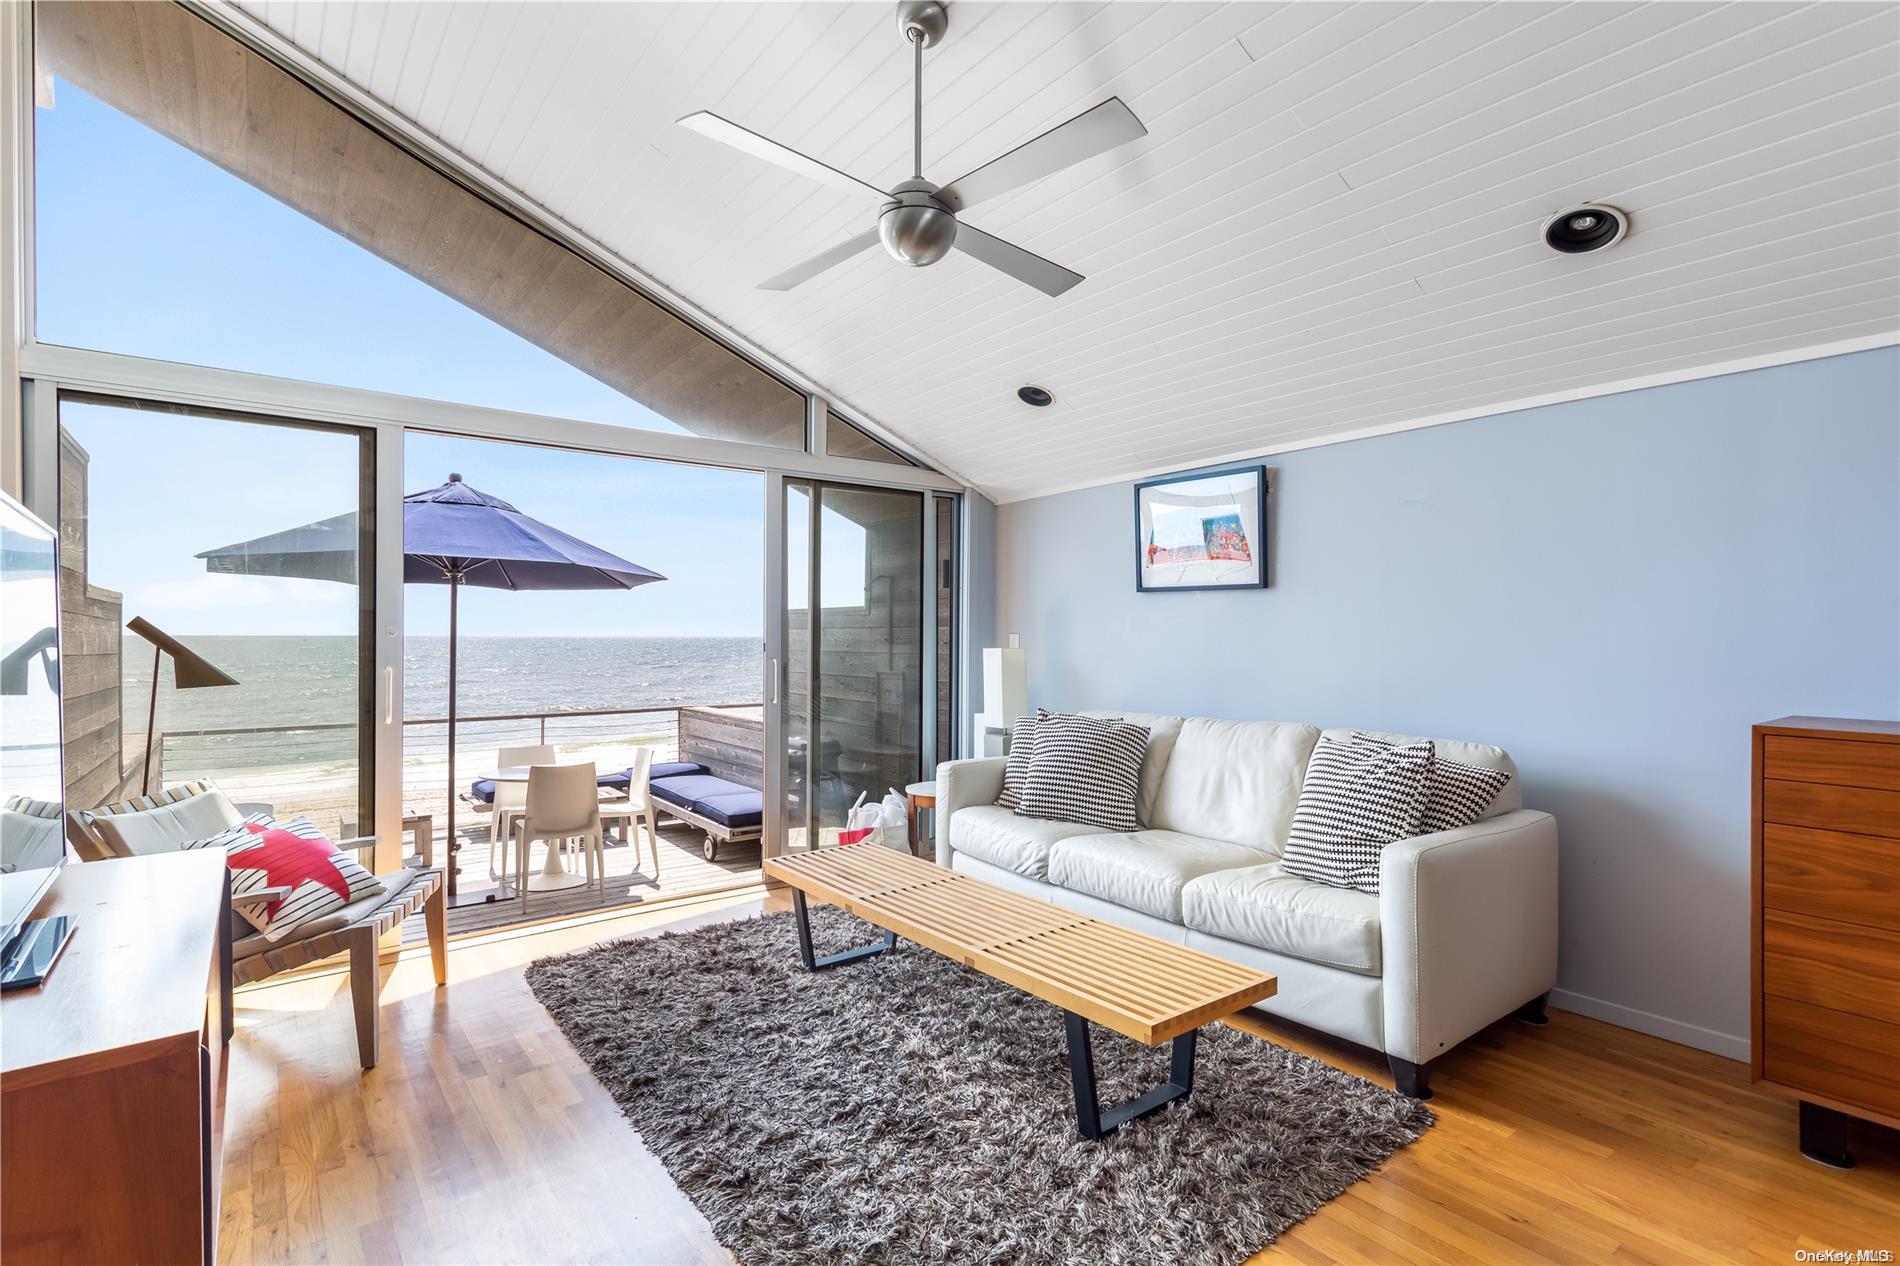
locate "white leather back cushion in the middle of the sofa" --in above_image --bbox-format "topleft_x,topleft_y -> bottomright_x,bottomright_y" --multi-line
1153,717 -> 1319,854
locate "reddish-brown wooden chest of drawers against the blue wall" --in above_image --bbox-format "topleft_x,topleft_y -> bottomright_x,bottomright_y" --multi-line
1750,717 -> 1900,1167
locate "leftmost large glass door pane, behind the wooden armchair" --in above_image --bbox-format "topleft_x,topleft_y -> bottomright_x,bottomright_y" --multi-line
59,399 -> 372,836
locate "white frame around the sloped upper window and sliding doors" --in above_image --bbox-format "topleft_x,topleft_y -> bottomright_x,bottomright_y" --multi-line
0,0 -> 973,869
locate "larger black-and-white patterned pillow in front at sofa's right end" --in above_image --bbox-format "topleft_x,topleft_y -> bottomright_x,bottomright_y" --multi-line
1281,734 -> 1433,893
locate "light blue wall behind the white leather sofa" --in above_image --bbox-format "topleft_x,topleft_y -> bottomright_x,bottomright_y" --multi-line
998,348 -> 1900,1057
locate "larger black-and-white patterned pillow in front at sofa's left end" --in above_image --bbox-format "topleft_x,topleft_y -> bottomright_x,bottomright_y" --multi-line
1015,713 -> 1148,831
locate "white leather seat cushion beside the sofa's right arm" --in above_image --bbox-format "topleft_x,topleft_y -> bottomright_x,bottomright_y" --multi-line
1182,861 -> 1379,975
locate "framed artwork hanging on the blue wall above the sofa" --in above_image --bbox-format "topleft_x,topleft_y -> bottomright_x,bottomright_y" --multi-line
1134,466 -> 1267,593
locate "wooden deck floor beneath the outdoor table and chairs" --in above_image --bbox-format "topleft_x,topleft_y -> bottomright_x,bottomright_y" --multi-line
403,815 -> 760,943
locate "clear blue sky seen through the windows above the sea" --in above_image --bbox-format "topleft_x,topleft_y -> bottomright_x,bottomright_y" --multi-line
34,80 -> 863,637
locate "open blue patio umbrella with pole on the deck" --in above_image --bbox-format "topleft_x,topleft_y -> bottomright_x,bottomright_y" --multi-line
198,475 -> 665,871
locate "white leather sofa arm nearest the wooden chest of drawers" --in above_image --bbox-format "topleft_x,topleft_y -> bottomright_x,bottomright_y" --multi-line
1379,810 -> 1556,1065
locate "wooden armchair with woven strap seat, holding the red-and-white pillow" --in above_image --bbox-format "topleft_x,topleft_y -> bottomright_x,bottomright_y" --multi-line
67,783 -> 448,1068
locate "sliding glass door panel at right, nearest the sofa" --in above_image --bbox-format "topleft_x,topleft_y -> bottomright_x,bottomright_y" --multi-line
766,477 -> 939,855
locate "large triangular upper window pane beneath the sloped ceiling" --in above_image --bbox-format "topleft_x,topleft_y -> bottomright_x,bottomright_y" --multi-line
34,2 -> 806,449
